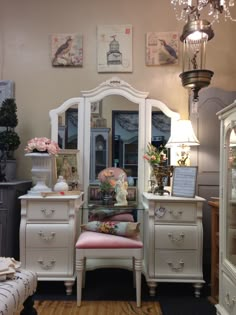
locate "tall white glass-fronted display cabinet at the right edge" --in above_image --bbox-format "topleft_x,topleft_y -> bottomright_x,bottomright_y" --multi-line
216,101 -> 236,315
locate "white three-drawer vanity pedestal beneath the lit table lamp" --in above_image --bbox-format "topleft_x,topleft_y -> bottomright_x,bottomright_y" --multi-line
143,192 -> 205,297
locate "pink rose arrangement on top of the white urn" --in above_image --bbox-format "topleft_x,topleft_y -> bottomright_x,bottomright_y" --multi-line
25,137 -> 60,154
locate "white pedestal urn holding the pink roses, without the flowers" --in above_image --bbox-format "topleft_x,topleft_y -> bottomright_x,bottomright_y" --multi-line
25,153 -> 52,195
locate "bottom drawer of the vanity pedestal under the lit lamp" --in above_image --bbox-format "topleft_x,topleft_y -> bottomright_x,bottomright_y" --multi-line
155,250 -> 202,279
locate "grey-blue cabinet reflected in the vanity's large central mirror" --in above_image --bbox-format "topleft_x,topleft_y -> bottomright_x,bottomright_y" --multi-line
90,128 -> 110,183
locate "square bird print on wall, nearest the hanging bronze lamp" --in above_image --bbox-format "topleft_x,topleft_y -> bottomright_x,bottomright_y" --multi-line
146,32 -> 179,66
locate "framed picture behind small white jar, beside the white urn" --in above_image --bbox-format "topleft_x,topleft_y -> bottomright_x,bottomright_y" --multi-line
56,149 -> 79,185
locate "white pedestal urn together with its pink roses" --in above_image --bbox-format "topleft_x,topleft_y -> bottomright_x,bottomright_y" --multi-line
25,137 -> 60,194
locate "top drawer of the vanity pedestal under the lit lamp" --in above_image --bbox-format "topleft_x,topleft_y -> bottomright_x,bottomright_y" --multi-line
155,202 -> 196,223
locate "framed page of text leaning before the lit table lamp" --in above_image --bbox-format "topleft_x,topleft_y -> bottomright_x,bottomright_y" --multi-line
171,166 -> 198,198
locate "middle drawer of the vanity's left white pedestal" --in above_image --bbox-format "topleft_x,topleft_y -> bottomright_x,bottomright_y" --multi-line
26,224 -> 70,248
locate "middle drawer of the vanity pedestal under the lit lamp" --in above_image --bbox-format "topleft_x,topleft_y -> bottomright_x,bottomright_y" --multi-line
155,225 -> 198,249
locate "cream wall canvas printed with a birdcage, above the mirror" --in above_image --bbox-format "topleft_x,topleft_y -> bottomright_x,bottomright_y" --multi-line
97,24 -> 133,72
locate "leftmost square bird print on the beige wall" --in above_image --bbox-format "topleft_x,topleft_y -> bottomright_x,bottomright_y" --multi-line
51,34 -> 83,67
